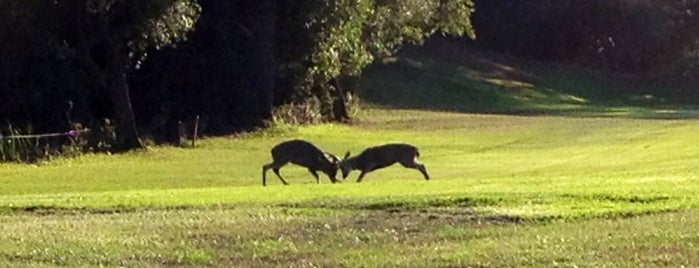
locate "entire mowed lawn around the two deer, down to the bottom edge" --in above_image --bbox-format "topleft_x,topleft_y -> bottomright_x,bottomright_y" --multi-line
0,108 -> 699,267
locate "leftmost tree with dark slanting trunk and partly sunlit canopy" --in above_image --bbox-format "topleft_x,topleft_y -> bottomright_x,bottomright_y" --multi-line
0,0 -> 200,151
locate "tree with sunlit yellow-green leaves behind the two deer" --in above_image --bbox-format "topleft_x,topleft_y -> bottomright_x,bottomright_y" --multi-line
279,0 -> 475,119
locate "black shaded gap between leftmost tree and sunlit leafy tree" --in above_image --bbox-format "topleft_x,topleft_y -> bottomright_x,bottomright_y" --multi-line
132,0 -> 277,136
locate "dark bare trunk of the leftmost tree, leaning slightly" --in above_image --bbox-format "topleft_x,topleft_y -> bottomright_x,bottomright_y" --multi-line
107,72 -> 143,152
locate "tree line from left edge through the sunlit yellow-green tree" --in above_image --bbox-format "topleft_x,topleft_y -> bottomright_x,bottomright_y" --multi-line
0,0 -> 473,151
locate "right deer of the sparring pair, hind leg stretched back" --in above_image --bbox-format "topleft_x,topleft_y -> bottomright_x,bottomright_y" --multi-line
340,143 -> 430,182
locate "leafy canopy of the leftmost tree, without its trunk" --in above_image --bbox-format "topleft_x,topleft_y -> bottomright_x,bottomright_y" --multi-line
0,0 -> 201,66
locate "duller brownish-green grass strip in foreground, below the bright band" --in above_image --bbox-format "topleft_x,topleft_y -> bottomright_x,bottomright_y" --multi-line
0,205 -> 699,267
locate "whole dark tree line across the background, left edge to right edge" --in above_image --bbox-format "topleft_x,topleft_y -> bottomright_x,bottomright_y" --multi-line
0,0 -> 699,157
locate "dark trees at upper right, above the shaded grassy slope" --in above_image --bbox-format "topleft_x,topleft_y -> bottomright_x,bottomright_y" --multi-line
473,0 -> 699,76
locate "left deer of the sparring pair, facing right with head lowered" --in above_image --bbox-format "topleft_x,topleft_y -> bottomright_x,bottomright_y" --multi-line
262,139 -> 340,186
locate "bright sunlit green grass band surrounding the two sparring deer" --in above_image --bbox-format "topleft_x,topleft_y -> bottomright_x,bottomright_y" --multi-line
0,110 -> 699,220
